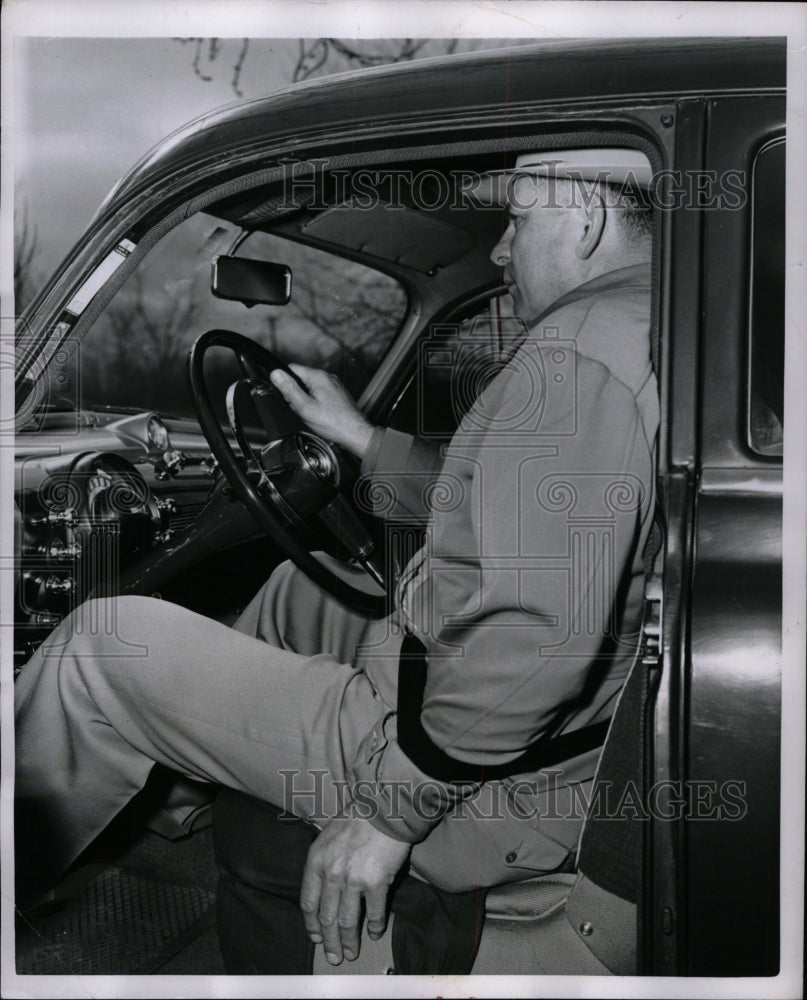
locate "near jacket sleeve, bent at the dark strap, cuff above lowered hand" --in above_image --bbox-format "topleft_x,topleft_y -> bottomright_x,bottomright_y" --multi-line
354,362 -> 653,842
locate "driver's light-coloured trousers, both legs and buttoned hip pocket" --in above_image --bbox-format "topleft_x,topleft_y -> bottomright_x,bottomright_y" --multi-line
15,564 -> 594,905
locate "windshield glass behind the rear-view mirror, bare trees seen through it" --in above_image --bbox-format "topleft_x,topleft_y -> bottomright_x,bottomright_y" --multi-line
55,214 -> 407,417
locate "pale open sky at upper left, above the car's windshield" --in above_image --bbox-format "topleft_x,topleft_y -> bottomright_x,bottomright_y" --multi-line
12,37 -> 334,272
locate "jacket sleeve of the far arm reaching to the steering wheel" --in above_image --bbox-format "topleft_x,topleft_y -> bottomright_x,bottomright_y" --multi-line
358,427 -> 443,523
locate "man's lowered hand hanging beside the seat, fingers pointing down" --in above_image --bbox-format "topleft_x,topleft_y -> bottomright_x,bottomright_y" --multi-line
300,816 -> 412,965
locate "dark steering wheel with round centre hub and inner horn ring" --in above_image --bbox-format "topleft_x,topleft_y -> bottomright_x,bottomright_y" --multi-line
188,330 -> 388,618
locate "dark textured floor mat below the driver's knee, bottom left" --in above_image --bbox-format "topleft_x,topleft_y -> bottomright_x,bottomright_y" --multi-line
17,869 -> 215,975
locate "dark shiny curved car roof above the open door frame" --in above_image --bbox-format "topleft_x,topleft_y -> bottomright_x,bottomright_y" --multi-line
104,38 -> 786,208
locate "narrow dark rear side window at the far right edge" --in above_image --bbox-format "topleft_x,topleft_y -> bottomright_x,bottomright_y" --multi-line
748,139 -> 785,455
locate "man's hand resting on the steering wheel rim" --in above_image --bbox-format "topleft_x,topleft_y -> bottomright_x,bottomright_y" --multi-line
271,365 -> 373,458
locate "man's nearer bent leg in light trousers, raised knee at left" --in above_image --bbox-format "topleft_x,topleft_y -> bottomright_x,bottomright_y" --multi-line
15,597 -> 382,916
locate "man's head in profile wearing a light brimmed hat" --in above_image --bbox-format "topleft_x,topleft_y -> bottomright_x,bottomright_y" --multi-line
477,149 -> 651,323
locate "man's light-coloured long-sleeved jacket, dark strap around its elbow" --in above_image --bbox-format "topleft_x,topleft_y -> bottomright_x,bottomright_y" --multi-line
353,265 -> 659,881
